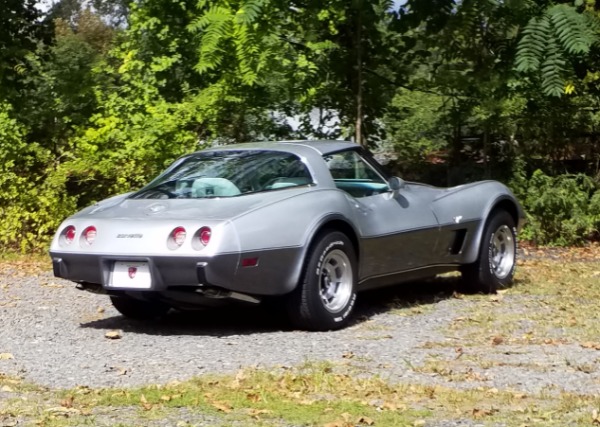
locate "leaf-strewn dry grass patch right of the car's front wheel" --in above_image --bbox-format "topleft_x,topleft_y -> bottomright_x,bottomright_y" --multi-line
442,261 -> 600,348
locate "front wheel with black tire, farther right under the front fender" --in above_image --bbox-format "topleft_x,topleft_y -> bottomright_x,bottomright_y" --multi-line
462,210 -> 517,294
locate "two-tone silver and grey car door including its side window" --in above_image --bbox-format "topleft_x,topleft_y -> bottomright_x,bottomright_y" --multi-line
324,151 -> 439,280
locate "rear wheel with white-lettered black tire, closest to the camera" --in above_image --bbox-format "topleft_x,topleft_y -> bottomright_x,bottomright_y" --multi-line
287,231 -> 357,331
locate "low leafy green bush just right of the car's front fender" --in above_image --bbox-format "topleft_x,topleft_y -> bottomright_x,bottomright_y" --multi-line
511,169 -> 600,246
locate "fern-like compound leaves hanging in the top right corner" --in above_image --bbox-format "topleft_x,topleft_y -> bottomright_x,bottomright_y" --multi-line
515,4 -> 598,96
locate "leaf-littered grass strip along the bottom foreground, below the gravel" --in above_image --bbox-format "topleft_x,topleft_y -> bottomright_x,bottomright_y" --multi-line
0,363 -> 600,427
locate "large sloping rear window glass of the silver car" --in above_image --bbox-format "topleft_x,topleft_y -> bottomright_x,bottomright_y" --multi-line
131,150 -> 313,199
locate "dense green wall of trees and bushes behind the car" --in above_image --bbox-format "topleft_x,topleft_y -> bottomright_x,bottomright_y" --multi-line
0,0 -> 600,252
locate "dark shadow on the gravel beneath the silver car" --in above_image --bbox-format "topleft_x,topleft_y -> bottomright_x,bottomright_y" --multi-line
81,277 -> 460,337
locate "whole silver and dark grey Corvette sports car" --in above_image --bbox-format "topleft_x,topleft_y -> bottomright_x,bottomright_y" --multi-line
50,141 -> 524,330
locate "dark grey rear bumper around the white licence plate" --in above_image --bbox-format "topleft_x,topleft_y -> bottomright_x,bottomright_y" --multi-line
50,248 -> 302,295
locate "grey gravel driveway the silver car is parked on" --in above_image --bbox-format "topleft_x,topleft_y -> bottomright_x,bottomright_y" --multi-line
0,268 -> 600,394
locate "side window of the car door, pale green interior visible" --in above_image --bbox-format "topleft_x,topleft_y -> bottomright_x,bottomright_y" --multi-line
323,151 -> 389,197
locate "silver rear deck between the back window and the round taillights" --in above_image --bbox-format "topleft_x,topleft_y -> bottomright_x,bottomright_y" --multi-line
72,191 -> 310,221
